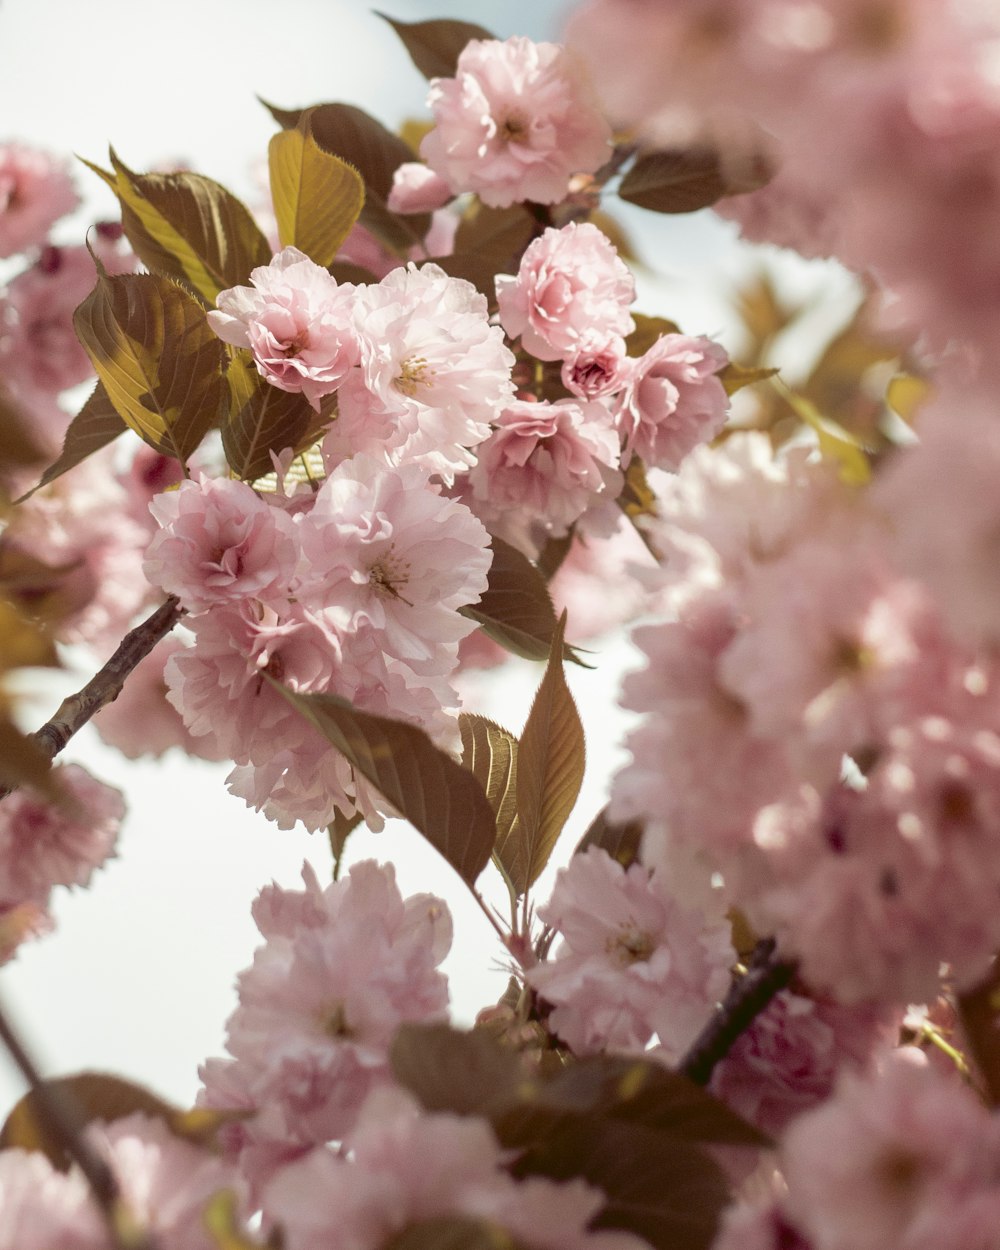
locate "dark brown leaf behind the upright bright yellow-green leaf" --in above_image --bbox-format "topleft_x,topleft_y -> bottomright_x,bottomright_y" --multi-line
266,104 -> 430,254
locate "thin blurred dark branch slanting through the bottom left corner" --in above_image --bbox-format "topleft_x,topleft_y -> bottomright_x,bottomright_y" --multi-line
0,1008 -> 155,1250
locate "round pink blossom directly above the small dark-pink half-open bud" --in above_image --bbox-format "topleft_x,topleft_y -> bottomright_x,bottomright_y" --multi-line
496,221 -> 632,368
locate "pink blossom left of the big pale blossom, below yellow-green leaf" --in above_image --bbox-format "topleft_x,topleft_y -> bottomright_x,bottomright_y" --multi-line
209,248 -> 359,411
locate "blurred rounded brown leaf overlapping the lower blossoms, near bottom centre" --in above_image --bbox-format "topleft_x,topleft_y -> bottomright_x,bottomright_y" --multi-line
389,1024 -> 525,1115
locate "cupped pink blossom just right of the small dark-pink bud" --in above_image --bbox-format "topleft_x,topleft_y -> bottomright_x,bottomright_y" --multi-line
618,334 -> 729,470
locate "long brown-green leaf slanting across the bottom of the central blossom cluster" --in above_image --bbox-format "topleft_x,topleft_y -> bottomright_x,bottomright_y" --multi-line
269,678 -> 496,885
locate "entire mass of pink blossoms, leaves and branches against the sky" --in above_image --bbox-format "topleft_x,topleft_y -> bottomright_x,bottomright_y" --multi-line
9,7 -> 1000,1250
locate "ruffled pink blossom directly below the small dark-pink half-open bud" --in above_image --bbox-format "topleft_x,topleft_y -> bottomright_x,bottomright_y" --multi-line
469,399 -> 621,555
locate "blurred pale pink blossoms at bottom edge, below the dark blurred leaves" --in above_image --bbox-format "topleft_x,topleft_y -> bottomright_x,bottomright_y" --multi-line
264,1089 -> 645,1250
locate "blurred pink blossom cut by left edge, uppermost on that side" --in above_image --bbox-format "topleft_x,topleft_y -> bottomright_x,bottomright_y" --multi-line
0,143 -> 80,259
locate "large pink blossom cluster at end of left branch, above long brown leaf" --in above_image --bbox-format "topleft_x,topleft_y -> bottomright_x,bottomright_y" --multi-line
145,455 -> 491,828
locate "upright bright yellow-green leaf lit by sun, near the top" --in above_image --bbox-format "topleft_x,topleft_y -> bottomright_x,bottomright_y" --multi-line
268,109 -> 365,265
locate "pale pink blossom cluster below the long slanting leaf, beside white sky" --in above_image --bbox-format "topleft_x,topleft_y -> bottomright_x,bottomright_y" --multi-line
201,861 -> 451,1180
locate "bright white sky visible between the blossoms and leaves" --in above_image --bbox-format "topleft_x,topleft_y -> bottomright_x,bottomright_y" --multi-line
0,0 -> 860,1118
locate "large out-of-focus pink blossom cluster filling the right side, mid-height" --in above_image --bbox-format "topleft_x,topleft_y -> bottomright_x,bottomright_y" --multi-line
613,435 -> 1000,1004
